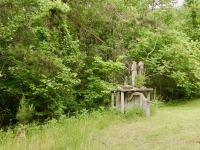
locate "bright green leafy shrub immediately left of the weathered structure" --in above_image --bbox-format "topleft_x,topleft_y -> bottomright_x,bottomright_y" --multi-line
84,57 -> 124,107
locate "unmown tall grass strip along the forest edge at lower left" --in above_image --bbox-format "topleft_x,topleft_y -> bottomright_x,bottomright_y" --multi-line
0,109 -> 143,150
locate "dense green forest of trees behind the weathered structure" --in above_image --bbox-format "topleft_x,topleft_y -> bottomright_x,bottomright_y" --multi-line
0,0 -> 200,126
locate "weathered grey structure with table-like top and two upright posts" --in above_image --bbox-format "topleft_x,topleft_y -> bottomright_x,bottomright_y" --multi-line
111,61 -> 153,116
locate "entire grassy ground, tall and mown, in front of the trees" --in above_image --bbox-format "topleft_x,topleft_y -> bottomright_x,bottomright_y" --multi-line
0,100 -> 200,150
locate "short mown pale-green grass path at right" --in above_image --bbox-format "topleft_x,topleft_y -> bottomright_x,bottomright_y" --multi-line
95,100 -> 200,150
